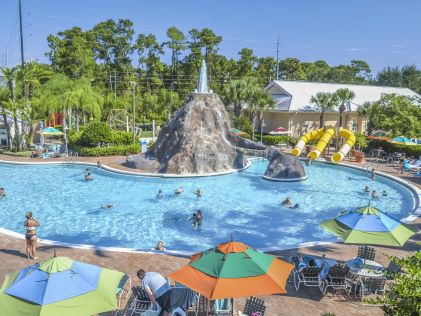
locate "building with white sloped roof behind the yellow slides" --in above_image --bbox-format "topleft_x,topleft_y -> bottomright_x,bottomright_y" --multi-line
263,80 -> 420,135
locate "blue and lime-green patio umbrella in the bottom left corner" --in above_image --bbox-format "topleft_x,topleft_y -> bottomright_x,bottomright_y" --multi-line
0,257 -> 124,316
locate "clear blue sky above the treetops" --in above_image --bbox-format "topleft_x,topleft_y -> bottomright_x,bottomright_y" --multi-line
0,0 -> 421,74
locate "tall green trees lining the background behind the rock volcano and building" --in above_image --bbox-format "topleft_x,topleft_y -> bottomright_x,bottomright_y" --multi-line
0,19 -> 421,152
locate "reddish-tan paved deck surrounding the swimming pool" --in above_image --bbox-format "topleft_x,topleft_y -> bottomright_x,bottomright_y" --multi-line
0,155 -> 421,316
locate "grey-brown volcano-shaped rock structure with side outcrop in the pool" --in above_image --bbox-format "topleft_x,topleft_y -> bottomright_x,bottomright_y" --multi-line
126,93 -> 306,181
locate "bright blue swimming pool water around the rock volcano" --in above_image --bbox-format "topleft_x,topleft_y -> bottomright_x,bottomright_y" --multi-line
0,161 -> 414,251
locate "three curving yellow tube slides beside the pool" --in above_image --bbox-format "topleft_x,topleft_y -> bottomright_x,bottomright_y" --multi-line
291,128 -> 355,163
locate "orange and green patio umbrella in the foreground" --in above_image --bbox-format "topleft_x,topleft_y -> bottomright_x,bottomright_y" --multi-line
170,241 -> 293,300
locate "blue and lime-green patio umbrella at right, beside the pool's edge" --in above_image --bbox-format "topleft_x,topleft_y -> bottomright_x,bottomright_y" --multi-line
320,205 -> 416,246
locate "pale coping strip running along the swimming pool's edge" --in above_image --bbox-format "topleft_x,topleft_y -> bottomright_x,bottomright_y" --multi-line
0,157 -> 421,257
